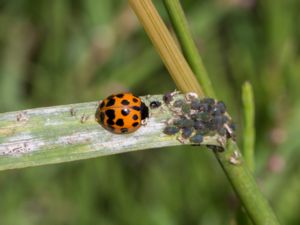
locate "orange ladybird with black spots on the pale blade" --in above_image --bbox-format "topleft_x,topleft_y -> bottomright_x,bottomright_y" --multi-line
95,93 -> 149,134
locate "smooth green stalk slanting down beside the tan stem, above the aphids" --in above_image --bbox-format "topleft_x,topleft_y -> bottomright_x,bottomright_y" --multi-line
163,0 -> 216,98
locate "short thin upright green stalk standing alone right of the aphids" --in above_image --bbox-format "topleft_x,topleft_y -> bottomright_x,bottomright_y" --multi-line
242,82 -> 255,173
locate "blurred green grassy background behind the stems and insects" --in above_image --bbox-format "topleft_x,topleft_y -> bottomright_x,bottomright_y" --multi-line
0,0 -> 300,225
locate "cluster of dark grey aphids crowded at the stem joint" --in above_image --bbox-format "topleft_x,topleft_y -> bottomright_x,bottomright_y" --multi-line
163,92 -> 234,144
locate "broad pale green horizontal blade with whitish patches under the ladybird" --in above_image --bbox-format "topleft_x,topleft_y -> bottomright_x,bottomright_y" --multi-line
0,95 -> 220,170
